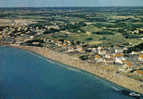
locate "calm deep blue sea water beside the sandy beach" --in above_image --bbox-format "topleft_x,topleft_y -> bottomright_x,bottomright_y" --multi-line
0,47 -> 142,99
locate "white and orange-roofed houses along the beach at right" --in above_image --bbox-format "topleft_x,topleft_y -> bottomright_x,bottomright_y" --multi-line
44,39 -> 143,74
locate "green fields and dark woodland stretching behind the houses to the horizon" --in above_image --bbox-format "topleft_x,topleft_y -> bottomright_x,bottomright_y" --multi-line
0,7 -> 143,46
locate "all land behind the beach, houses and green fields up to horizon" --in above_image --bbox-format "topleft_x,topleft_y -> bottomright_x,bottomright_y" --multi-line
0,7 -> 143,82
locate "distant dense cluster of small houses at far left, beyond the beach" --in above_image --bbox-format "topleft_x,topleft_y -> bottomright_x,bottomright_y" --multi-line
0,24 -> 59,44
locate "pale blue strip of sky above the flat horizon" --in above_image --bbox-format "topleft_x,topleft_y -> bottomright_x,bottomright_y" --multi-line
0,0 -> 143,7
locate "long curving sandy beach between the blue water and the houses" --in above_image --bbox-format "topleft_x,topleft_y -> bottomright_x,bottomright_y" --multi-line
11,45 -> 143,94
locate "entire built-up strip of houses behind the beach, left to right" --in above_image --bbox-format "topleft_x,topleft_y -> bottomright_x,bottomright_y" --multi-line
0,21 -> 143,80
